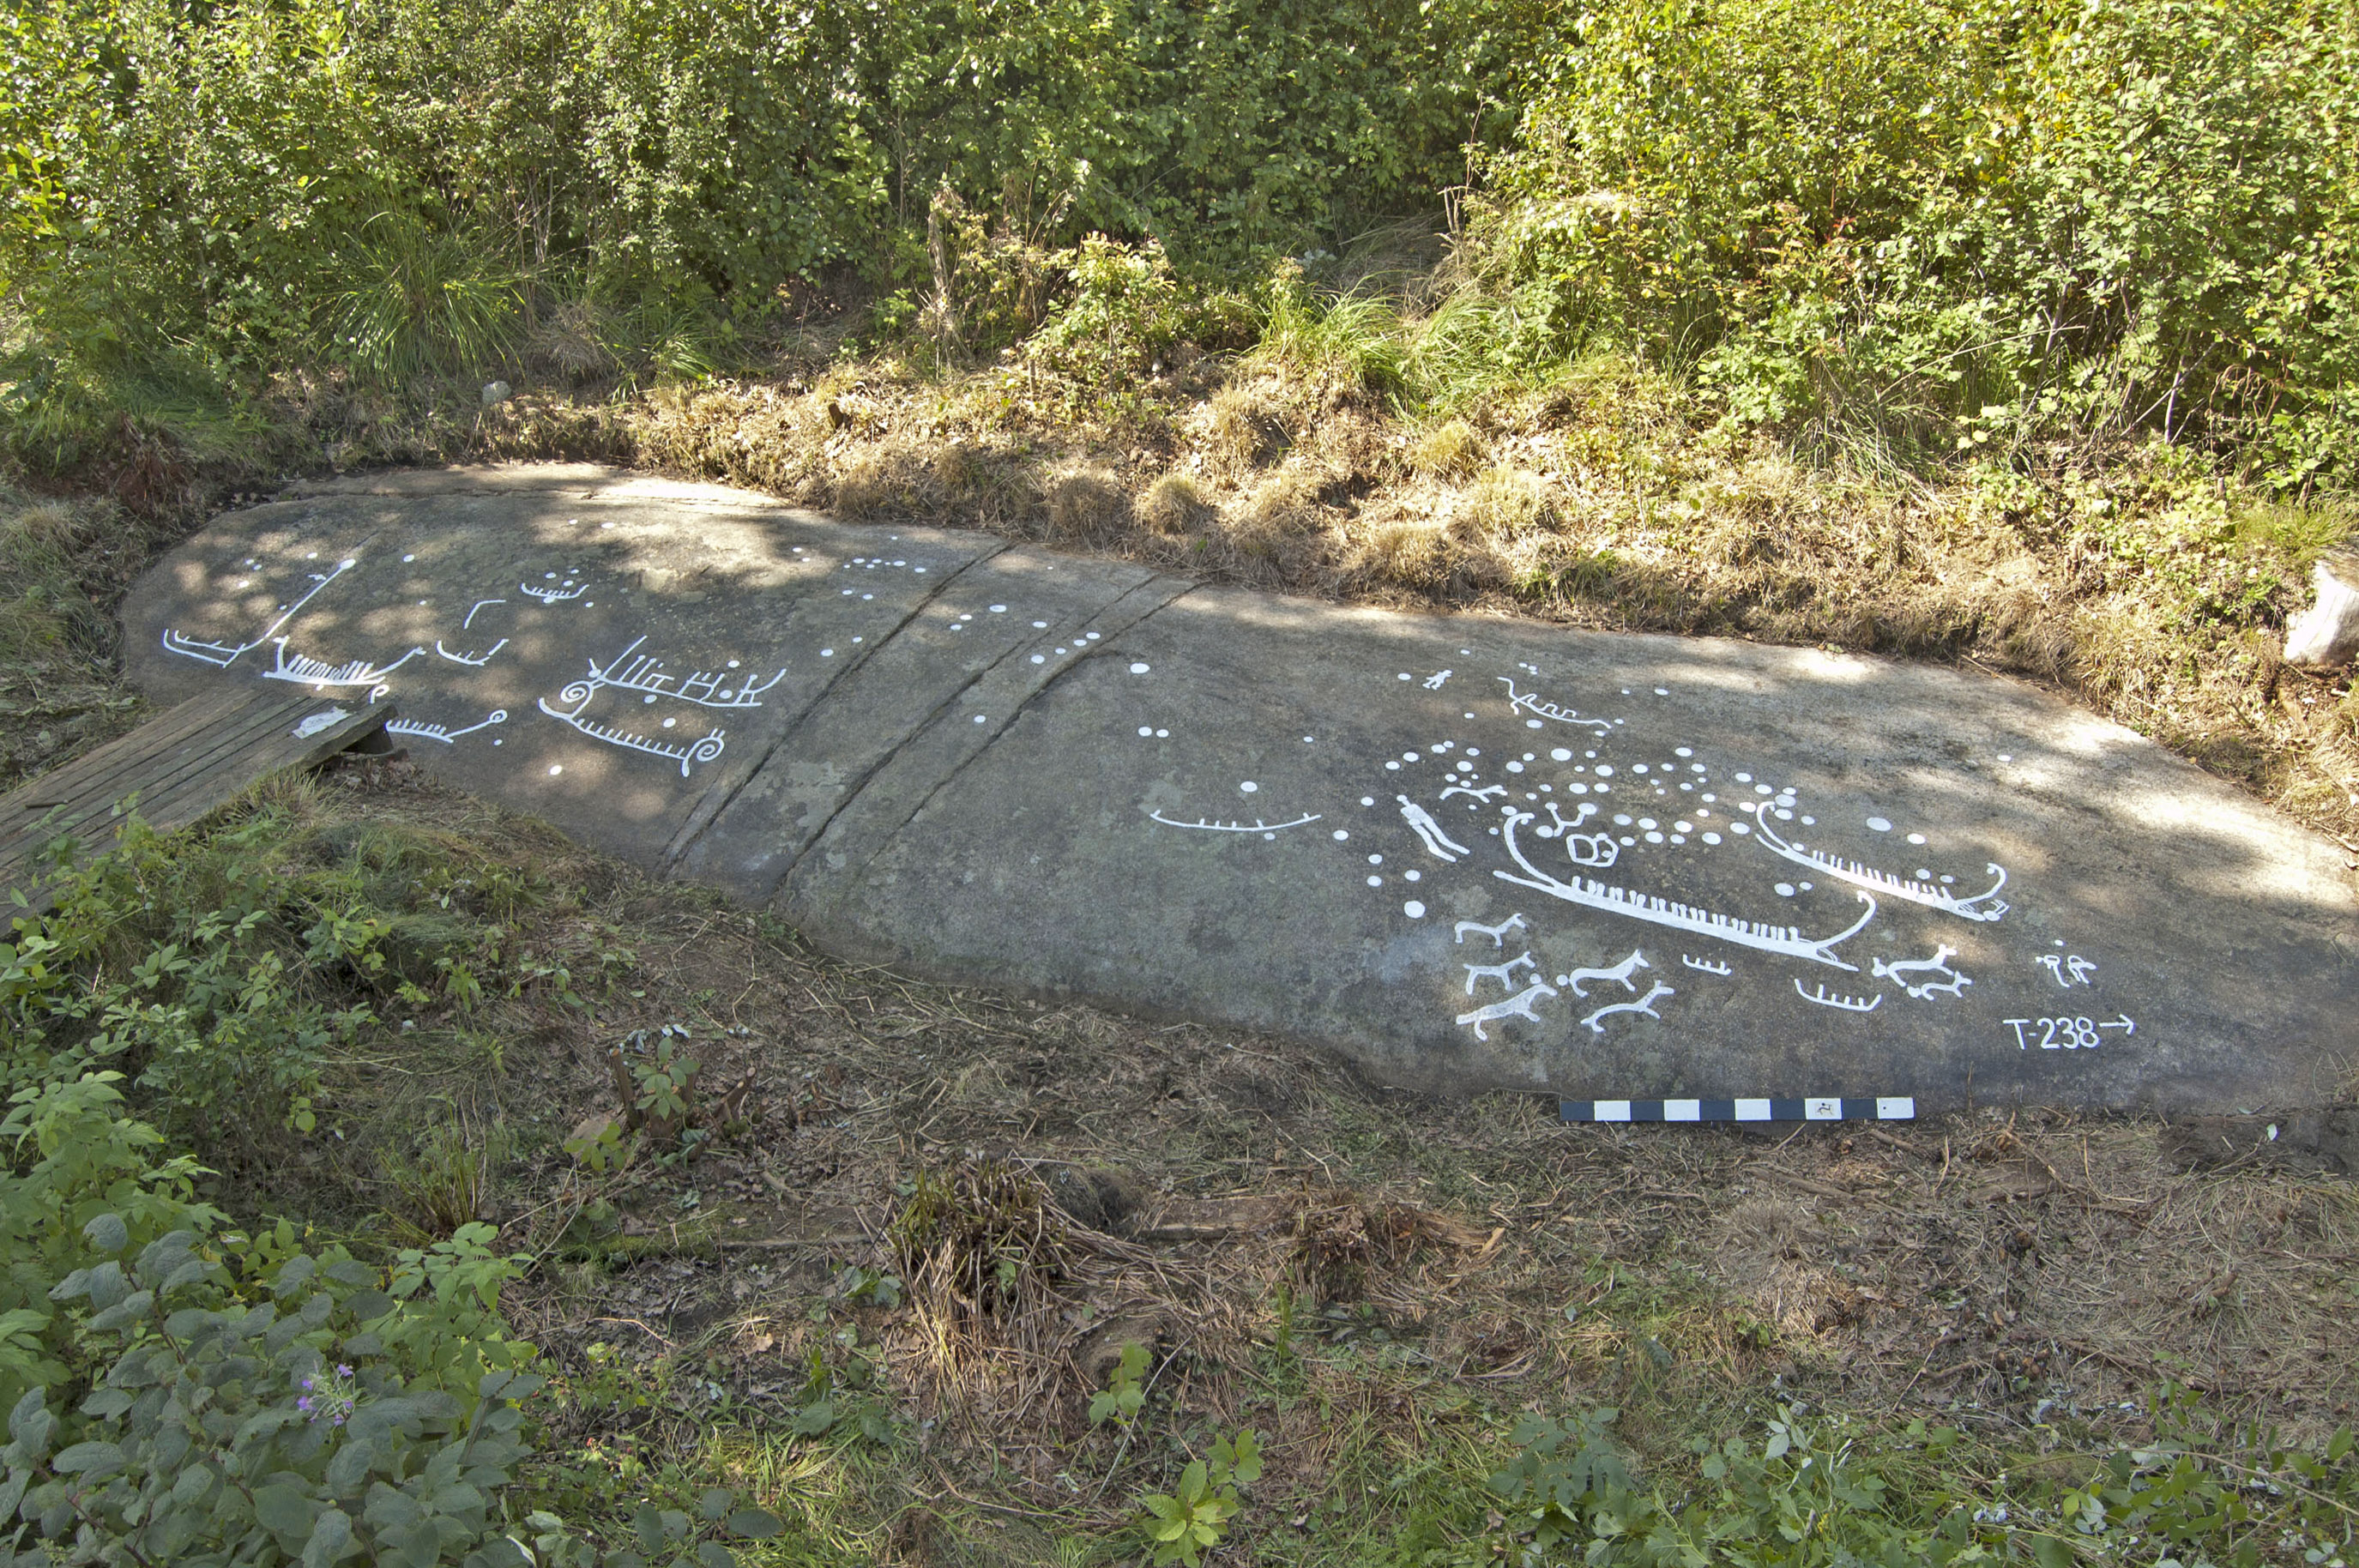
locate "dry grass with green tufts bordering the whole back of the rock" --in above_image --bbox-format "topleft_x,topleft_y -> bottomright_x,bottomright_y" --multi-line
22,262 -> 2359,863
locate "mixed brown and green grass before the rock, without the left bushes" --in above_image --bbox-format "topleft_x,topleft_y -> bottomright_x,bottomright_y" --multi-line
0,716 -> 2359,1565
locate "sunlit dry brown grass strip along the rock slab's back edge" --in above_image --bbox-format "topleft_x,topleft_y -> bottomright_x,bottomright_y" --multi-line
526,359 -> 2359,840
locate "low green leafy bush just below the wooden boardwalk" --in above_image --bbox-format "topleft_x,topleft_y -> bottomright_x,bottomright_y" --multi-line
0,806 -> 554,1143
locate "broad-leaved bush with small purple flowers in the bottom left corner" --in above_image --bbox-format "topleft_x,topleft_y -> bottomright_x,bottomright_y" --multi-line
0,1192 -> 781,1568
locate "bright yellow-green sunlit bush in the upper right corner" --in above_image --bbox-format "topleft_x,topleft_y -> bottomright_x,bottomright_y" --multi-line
1481,0 -> 2359,485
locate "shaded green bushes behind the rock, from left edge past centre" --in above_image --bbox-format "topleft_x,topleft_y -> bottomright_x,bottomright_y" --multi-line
0,0 -> 1510,467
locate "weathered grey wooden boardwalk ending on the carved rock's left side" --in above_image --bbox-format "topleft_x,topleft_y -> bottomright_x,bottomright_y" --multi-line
0,686 -> 394,929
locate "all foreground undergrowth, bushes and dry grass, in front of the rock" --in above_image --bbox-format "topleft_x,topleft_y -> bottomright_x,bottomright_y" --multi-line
0,762 -> 2359,1568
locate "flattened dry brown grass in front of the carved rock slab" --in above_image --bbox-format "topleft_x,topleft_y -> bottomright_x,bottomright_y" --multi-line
212,764 -> 2359,1526
